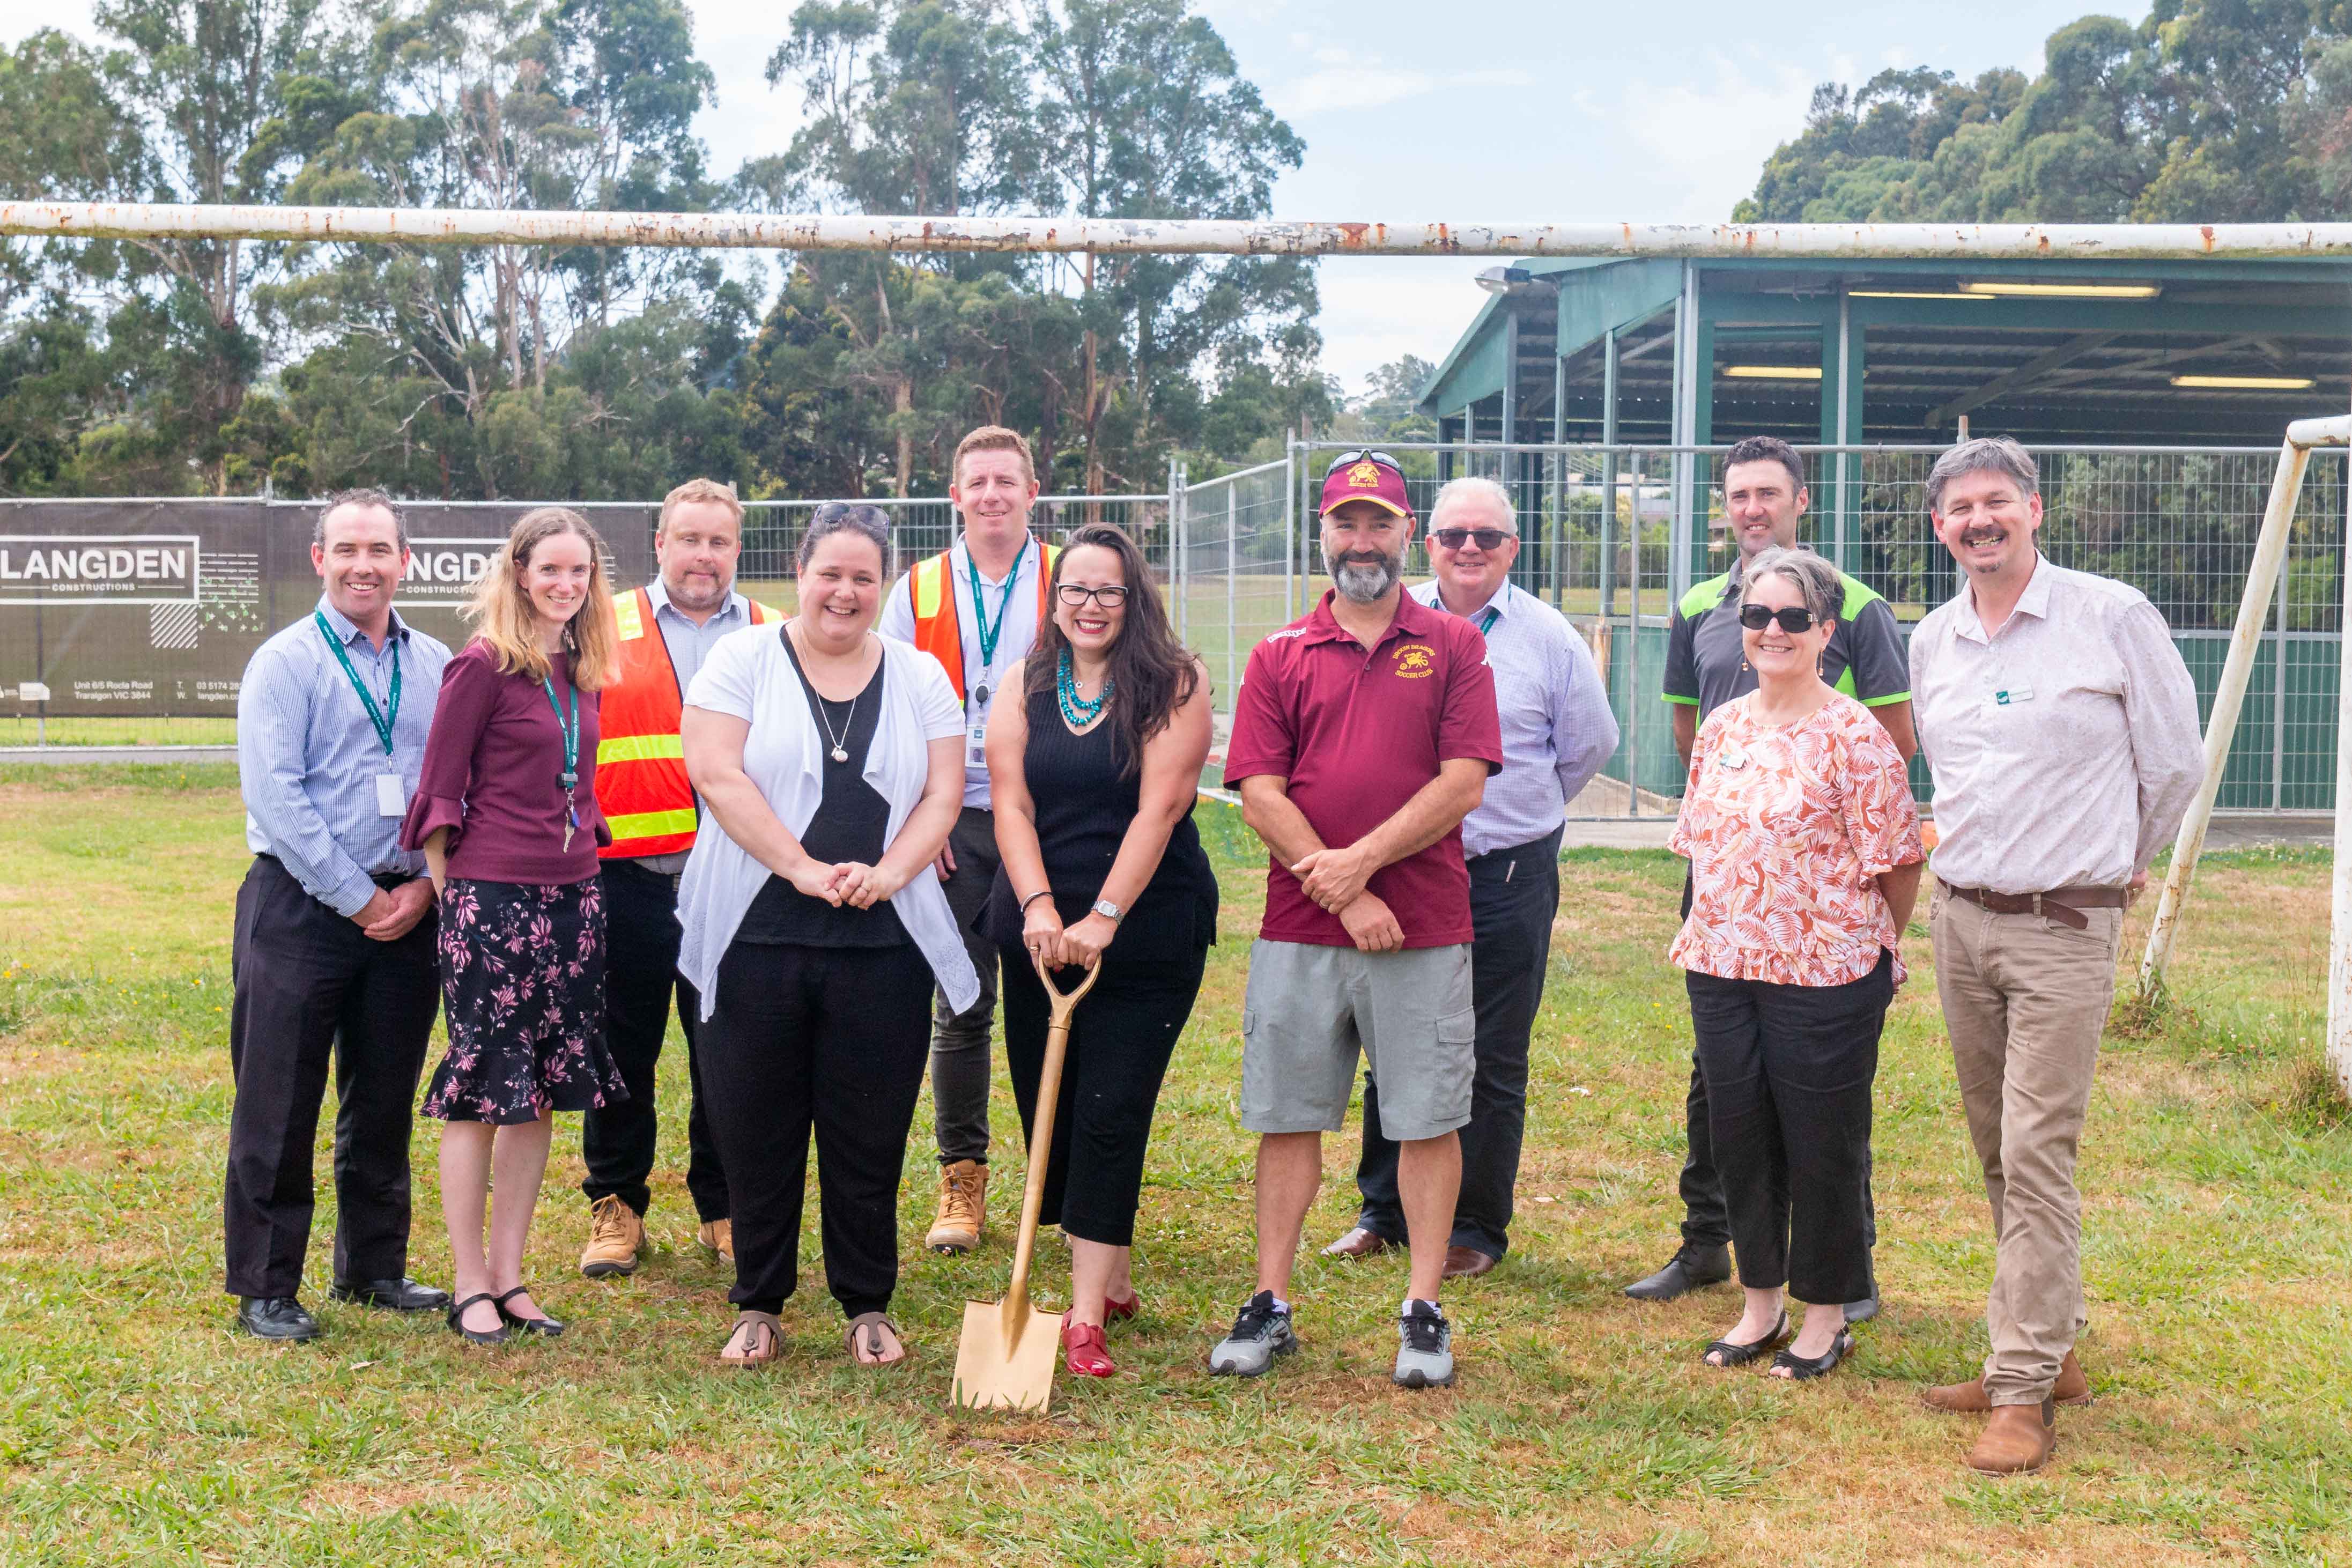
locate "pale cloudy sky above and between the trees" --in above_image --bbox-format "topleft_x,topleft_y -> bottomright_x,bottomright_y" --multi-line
0,0 -> 2147,395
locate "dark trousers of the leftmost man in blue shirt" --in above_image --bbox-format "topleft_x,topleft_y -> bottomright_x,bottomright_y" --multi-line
221,856 -> 440,1295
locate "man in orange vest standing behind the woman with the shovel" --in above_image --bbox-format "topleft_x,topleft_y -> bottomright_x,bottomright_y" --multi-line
877,425 -> 1056,1253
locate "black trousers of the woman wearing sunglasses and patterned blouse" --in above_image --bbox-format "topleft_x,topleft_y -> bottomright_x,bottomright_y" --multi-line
1684,952 -> 1896,1305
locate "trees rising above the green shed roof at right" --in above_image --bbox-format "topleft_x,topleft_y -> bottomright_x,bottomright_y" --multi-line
1733,0 -> 2352,223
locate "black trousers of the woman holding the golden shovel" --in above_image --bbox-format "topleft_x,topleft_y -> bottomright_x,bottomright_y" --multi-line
1002,943 -> 1209,1246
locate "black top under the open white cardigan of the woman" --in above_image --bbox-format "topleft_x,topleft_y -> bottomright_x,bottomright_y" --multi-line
736,625 -> 913,948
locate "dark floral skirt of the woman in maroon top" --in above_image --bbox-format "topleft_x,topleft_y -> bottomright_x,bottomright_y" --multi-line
426,877 -> 628,1126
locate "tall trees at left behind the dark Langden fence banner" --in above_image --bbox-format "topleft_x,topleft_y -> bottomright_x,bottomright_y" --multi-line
0,0 -> 1336,498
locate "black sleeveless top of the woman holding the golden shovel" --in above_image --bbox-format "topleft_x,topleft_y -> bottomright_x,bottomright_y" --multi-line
981,686 -> 1216,961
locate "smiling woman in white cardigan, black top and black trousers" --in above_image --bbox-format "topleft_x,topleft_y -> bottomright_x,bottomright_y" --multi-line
677,506 -> 979,1366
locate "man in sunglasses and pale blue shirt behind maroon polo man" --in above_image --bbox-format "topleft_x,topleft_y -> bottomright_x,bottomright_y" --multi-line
1324,479 -> 1618,1279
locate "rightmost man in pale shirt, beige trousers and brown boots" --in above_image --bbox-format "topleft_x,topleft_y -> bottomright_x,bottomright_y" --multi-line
1910,437 -> 2204,1474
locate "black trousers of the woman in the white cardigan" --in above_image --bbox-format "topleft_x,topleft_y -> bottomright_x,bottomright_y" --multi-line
701,943 -> 931,1316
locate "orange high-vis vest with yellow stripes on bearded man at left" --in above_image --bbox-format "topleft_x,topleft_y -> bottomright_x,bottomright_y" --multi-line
595,588 -> 781,860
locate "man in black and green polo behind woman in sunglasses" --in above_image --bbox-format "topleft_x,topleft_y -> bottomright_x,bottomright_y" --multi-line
1625,435 -> 1919,1321
